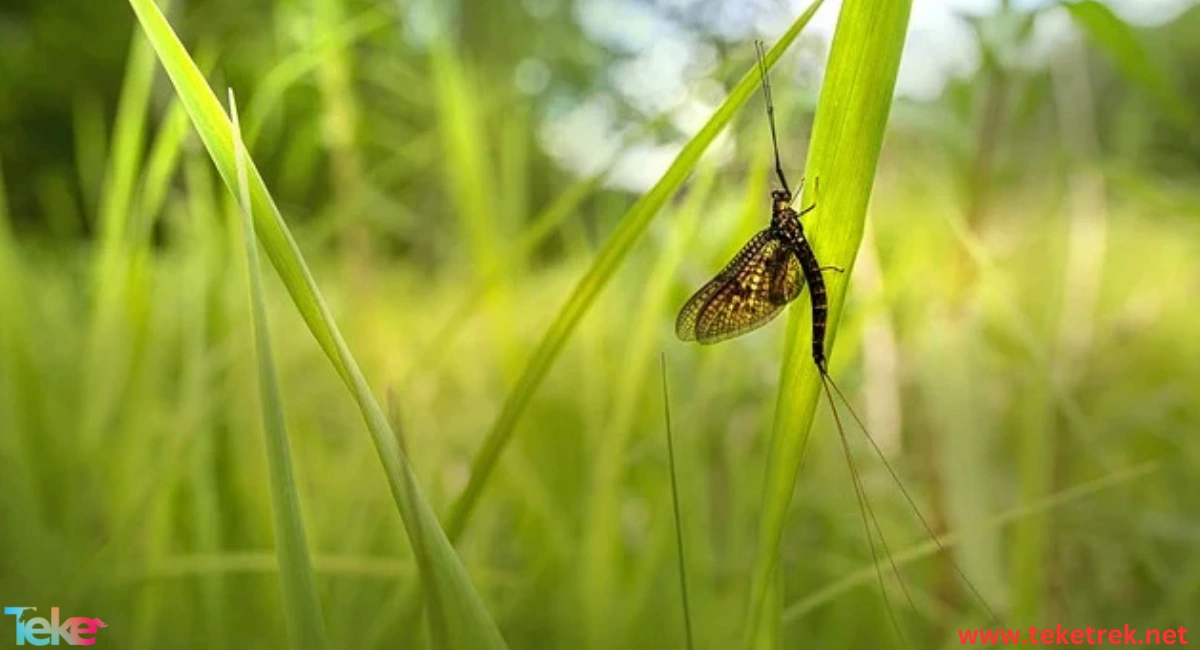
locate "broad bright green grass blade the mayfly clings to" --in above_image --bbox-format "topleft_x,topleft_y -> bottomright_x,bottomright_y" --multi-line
745,0 -> 911,648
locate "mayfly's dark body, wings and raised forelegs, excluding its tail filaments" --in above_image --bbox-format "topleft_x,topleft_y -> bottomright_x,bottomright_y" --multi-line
676,41 -> 842,373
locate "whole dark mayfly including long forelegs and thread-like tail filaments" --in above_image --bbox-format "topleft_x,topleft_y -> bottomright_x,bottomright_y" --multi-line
676,41 -> 997,639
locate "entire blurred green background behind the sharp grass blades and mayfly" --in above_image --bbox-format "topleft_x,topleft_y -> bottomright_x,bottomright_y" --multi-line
0,0 -> 1200,649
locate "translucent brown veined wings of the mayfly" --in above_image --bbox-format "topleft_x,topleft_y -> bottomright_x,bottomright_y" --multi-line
676,228 -> 804,343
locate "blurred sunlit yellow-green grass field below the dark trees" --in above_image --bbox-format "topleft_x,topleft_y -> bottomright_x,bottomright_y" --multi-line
0,0 -> 1200,649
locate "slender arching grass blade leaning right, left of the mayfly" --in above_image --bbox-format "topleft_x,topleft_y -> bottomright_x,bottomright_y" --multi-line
446,0 -> 823,540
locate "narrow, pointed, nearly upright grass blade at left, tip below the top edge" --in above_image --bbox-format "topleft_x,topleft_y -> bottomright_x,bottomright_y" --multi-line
229,90 -> 329,650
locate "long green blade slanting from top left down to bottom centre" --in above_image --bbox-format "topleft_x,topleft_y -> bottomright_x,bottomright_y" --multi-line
130,0 -> 505,650
